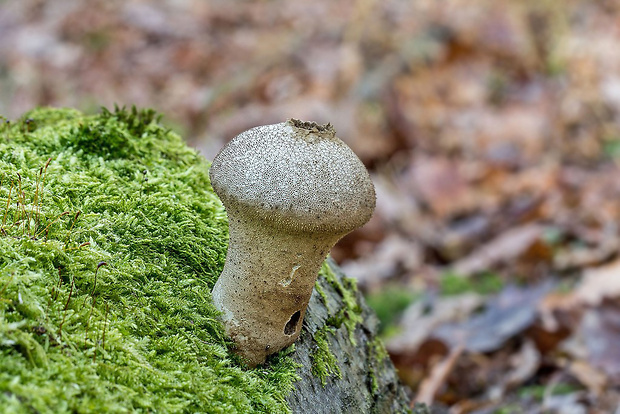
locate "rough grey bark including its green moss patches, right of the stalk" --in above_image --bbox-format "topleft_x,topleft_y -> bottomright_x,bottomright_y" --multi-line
287,258 -> 415,413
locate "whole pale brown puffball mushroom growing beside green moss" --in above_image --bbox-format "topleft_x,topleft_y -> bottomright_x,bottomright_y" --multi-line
209,119 -> 375,367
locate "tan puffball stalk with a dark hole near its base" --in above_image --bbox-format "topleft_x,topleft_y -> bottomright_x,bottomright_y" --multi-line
213,213 -> 336,366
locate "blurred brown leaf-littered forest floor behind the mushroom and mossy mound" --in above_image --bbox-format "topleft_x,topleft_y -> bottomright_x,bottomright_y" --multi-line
0,0 -> 620,413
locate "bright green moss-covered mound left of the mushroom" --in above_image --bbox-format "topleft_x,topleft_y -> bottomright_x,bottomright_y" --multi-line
0,109 -> 296,413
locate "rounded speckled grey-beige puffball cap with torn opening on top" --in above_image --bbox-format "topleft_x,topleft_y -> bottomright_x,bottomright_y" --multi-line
209,119 -> 376,235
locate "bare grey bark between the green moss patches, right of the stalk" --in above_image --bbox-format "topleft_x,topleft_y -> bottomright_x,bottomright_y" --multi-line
288,259 -> 429,414
